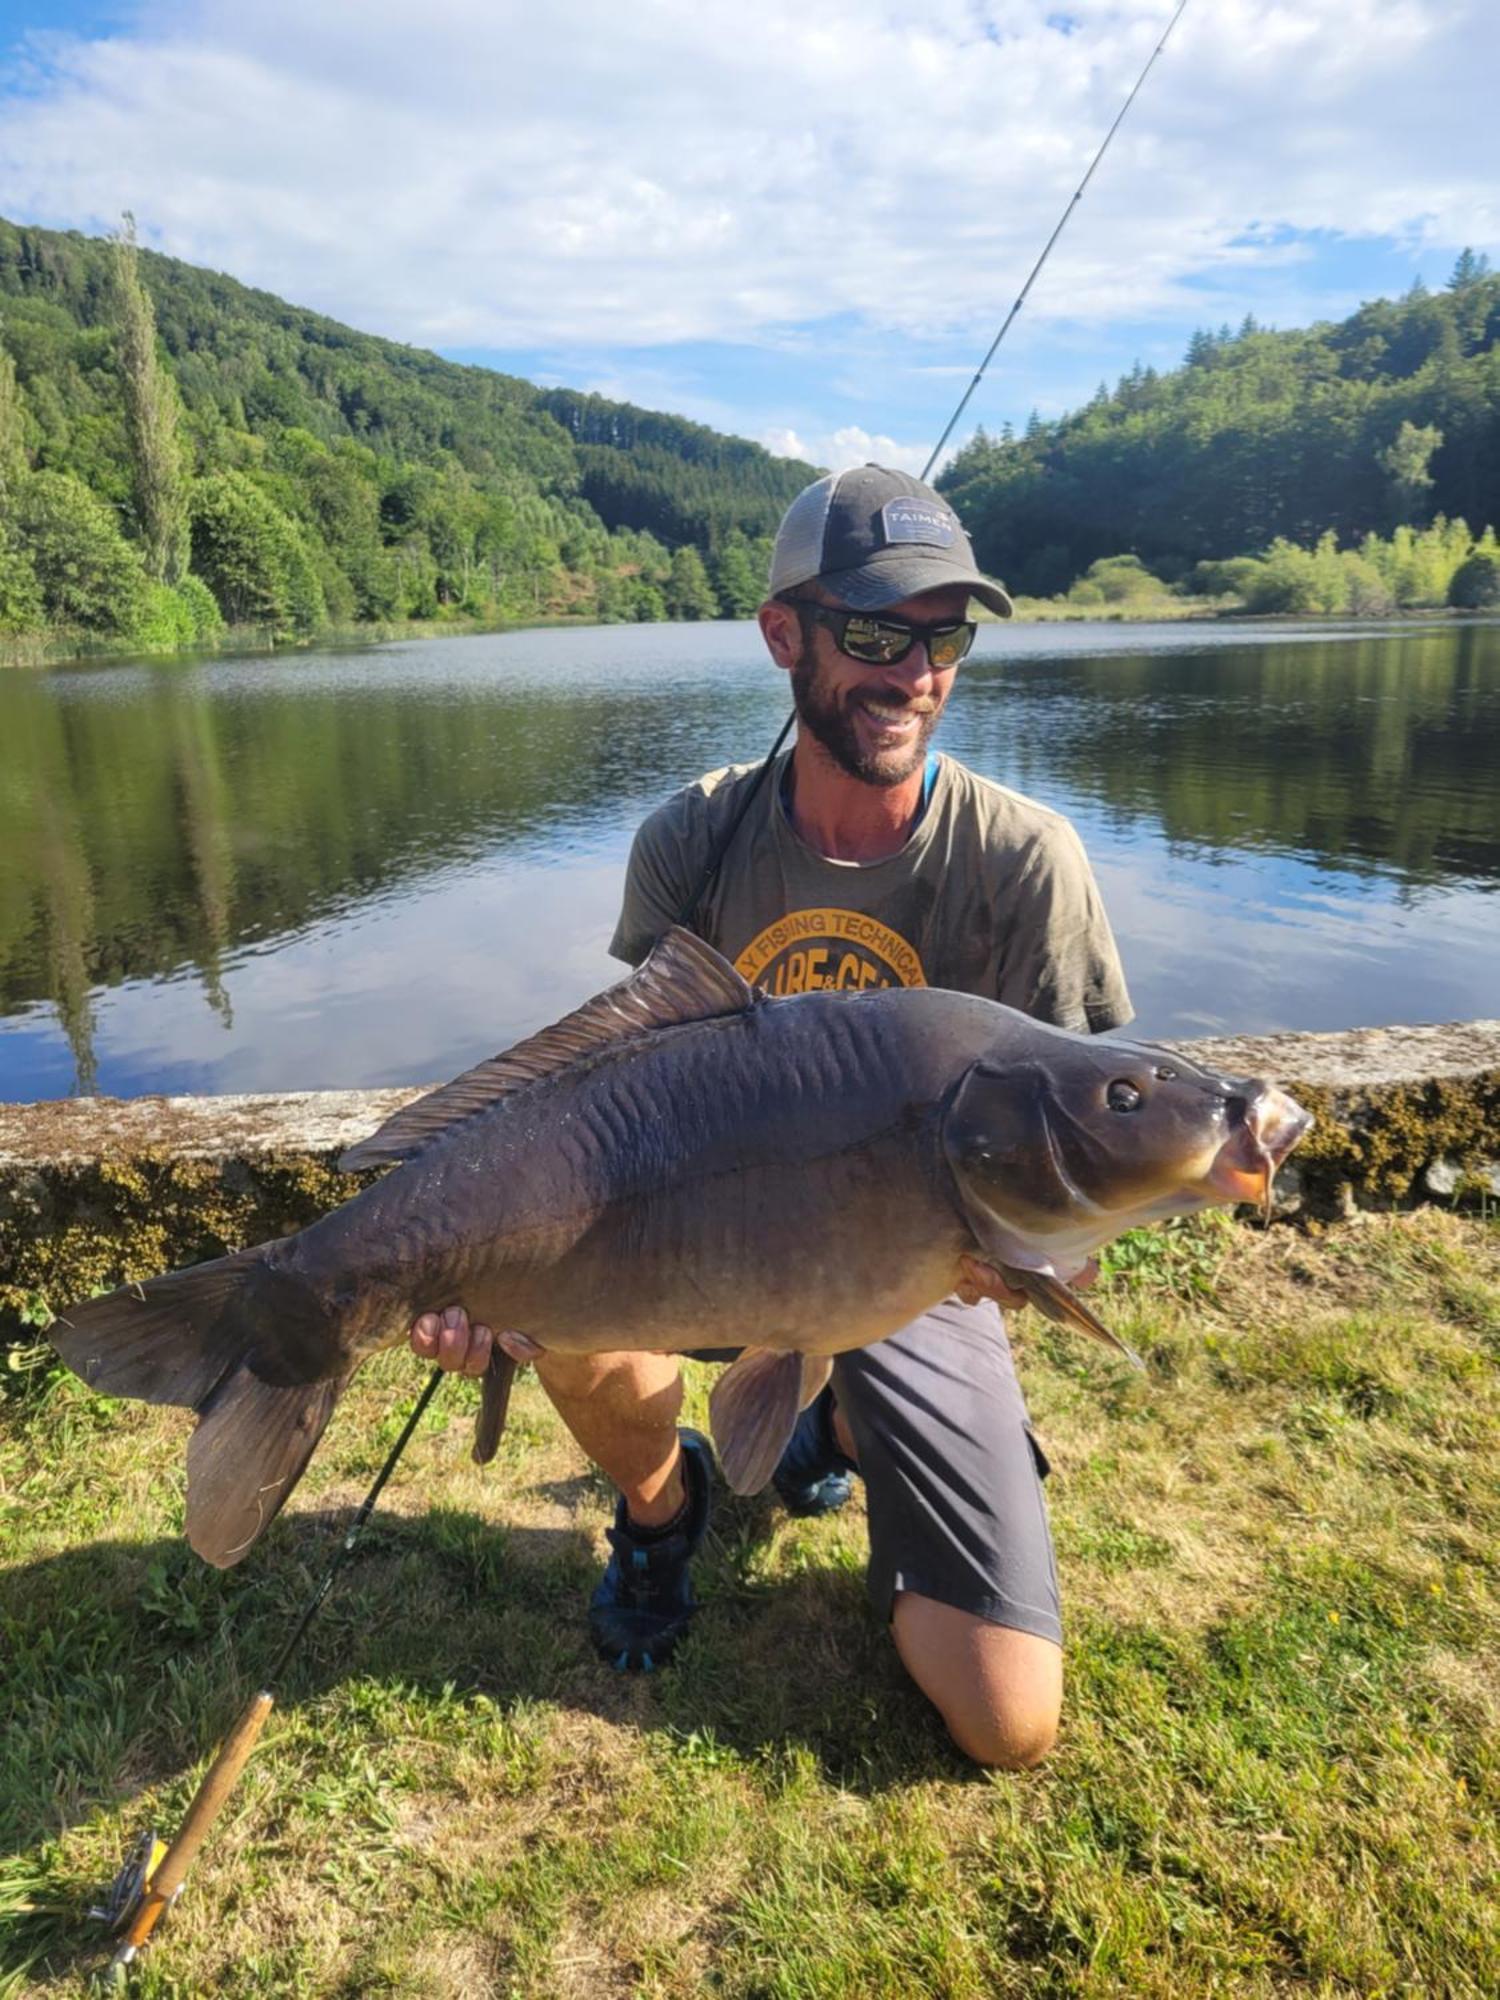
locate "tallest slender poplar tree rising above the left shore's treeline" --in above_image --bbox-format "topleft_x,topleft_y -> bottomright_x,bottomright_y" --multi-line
114,212 -> 188,584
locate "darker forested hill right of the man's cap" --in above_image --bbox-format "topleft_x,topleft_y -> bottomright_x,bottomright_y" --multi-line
940,252 -> 1500,596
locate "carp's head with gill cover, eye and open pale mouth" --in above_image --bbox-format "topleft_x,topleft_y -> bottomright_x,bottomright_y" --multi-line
942,1036 -> 1312,1264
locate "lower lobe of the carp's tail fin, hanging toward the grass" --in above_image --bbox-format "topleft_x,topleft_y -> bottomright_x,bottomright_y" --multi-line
188,1362 -> 348,1570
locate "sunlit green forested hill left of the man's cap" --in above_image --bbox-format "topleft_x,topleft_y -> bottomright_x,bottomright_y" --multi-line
0,220 -> 816,644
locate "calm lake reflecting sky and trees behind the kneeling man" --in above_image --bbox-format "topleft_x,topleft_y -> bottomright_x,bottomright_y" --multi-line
0,622 -> 1500,1098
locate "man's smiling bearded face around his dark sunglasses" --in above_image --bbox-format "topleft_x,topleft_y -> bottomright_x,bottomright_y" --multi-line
792,588 -> 968,786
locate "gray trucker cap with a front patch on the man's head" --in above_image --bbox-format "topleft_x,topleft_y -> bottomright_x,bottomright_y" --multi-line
770,466 -> 1012,618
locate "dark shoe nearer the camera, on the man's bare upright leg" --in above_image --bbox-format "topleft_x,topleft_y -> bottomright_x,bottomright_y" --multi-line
588,1430 -> 714,1674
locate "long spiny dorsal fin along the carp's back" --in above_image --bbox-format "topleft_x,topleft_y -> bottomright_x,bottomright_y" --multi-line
338,924 -> 758,1174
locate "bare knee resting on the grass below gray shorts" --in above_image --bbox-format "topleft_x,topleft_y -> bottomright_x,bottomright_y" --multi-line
892,1590 -> 1062,1770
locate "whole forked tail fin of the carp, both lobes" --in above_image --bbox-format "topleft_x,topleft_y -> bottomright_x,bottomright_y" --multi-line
48,1250 -> 350,1568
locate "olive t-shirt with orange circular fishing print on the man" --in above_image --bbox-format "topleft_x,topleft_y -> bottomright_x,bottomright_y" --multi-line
610,752 -> 1132,1034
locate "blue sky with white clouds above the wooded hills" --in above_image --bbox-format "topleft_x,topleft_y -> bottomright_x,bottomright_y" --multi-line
0,0 -> 1500,464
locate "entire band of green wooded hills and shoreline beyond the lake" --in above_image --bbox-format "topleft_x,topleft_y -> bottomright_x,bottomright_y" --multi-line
0,216 -> 1500,664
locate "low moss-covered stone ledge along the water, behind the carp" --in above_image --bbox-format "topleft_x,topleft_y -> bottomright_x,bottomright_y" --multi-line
0,1020 -> 1500,1340
